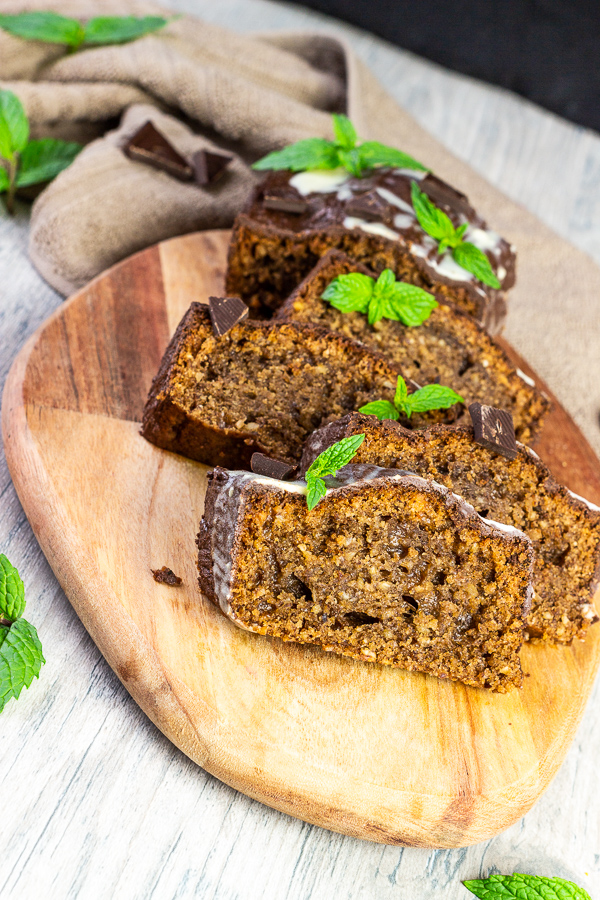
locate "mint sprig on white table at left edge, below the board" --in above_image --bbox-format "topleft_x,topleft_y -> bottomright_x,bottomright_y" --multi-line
0,553 -> 46,713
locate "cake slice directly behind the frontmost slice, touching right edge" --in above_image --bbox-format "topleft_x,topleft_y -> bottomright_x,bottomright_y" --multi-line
301,414 -> 600,643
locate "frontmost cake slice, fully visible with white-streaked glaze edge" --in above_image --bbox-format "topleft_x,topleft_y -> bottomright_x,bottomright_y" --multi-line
198,464 -> 532,692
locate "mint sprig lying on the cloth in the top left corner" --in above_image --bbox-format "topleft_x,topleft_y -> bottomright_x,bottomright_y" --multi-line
0,11 -> 169,51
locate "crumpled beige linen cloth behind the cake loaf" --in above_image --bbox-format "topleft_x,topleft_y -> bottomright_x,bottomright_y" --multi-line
0,0 -> 600,452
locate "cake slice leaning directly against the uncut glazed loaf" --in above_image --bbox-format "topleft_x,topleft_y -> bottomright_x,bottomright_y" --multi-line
275,250 -> 549,443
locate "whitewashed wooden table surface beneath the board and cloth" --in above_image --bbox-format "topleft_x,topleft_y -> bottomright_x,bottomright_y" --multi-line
0,0 -> 600,900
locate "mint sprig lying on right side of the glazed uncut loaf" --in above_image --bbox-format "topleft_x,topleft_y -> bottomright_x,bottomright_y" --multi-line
410,181 -> 500,288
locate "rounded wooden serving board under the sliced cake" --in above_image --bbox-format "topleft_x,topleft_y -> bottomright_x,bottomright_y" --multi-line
2,232 -> 600,847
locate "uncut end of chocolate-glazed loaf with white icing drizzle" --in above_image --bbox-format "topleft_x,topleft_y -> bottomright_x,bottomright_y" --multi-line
227,166 -> 515,332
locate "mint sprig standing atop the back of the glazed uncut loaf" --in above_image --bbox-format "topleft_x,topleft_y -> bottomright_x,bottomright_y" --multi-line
252,113 -> 428,178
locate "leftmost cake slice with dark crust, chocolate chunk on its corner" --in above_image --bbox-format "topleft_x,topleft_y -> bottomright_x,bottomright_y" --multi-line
142,303 -> 406,468
